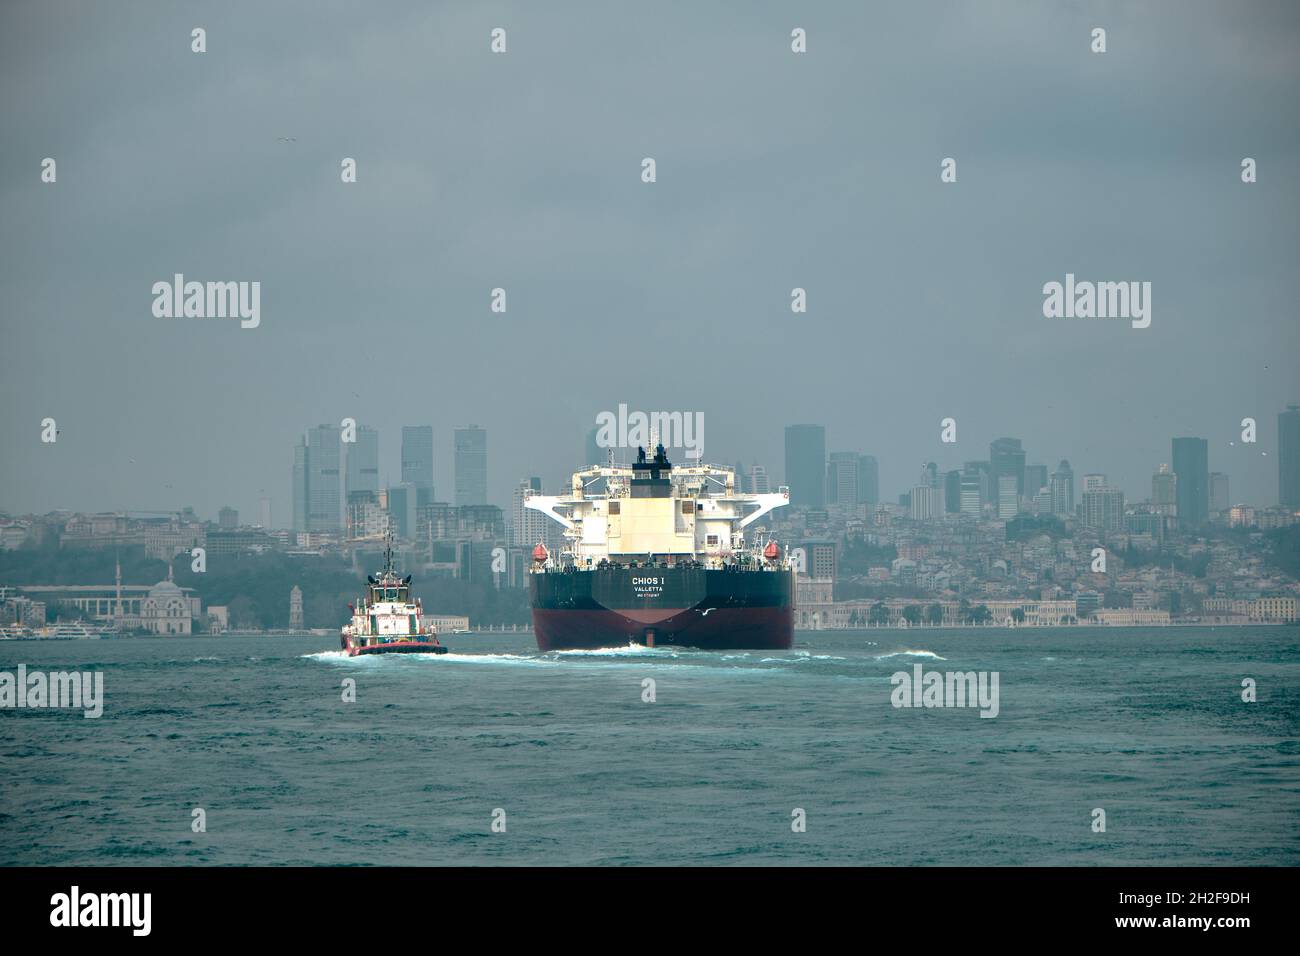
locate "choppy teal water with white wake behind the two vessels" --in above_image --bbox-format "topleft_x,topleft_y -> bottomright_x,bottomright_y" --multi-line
0,628 -> 1300,865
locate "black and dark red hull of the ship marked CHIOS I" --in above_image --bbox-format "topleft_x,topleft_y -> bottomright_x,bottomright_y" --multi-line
529,568 -> 794,650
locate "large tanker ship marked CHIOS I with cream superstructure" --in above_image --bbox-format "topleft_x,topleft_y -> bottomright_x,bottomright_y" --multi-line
524,445 -> 794,650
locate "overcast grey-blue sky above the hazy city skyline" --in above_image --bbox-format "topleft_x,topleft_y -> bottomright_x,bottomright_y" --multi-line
0,0 -> 1300,525
